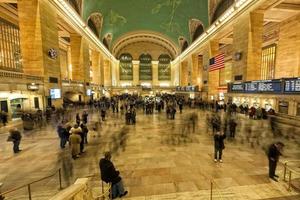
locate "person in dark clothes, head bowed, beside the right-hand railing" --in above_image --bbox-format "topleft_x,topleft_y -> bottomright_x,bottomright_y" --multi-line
268,142 -> 284,182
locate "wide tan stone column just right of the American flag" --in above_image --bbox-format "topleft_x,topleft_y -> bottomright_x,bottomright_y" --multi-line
232,12 -> 264,81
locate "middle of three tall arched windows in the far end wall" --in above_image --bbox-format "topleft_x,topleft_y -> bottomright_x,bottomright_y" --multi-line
139,54 -> 152,81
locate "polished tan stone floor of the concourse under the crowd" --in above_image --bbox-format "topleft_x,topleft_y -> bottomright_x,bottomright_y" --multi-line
0,109 -> 300,200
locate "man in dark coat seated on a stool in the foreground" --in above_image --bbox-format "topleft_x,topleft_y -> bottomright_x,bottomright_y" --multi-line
99,152 -> 128,199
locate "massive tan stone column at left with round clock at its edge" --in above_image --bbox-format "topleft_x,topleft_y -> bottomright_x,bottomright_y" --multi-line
18,0 -> 62,107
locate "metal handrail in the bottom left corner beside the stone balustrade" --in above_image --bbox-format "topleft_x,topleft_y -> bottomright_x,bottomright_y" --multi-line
0,168 -> 62,200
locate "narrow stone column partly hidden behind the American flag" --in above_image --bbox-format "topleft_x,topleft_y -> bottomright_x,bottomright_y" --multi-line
207,40 -> 220,100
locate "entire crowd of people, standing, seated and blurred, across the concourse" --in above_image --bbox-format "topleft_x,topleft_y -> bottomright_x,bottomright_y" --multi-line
0,94 -> 284,198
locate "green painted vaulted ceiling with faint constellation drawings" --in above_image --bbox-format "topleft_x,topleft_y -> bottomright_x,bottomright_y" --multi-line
83,0 -> 208,44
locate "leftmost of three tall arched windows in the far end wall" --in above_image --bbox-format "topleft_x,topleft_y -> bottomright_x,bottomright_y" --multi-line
119,53 -> 133,81
